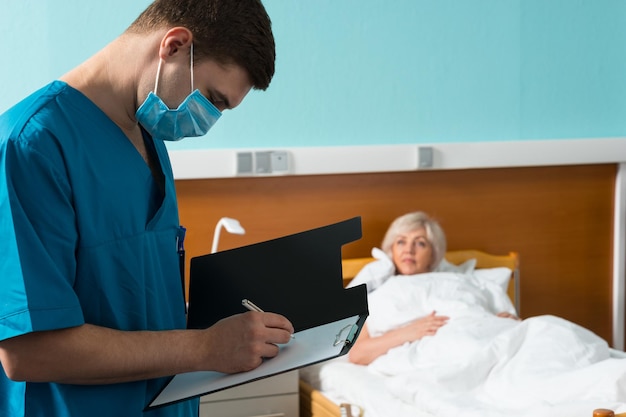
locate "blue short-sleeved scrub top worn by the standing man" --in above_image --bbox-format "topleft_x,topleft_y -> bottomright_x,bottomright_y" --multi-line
0,81 -> 198,417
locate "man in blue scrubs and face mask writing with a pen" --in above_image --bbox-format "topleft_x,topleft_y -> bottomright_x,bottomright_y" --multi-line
0,0 -> 293,417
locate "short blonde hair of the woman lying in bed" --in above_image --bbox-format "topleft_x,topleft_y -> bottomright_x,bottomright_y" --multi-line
381,211 -> 447,270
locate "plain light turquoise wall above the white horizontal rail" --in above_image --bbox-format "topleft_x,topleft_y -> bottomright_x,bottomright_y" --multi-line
0,0 -> 626,149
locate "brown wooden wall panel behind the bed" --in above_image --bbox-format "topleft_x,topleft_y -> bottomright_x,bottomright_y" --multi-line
177,164 -> 617,342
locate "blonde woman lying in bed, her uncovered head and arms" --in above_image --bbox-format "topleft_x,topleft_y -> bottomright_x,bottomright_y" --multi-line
349,211 -> 517,365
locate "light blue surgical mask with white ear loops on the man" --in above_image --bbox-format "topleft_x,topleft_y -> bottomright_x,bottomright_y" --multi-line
135,44 -> 222,141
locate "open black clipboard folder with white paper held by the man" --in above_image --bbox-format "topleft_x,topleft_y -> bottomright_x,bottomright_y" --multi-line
146,217 -> 368,409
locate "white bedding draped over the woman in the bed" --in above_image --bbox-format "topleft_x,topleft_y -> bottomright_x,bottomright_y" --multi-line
304,273 -> 626,417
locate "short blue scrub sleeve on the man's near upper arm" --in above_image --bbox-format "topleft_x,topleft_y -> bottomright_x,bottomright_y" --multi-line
0,130 -> 84,340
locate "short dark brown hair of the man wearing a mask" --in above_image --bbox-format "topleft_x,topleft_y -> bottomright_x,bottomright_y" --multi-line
127,0 -> 276,90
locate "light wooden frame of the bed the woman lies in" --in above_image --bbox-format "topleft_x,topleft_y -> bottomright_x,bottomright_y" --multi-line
299,250 -> 626,417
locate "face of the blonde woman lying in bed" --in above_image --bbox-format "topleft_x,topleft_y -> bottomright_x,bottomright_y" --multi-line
391,227 -> 433,275
